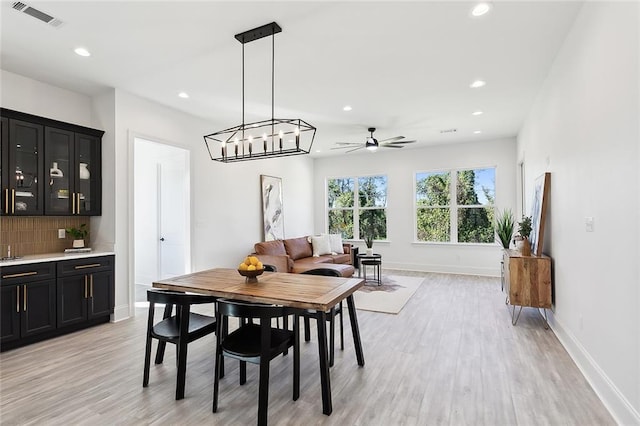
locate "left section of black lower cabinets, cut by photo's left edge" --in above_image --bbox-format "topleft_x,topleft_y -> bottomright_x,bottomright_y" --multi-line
0,262 -> 56,346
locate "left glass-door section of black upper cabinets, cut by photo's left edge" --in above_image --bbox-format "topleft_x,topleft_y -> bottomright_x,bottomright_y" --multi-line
0,117 -> 43,216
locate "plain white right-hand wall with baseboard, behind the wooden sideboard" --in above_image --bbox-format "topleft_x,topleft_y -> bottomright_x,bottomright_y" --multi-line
518,2 -> 640,424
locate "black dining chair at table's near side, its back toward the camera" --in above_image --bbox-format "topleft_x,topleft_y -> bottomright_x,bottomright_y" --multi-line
213,299 -> 300,425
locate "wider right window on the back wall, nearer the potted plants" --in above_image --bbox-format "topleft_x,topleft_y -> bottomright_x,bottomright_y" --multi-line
415,168 -> 495,243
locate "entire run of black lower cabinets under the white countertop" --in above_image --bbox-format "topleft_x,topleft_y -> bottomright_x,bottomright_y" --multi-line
0,255 -> 115,350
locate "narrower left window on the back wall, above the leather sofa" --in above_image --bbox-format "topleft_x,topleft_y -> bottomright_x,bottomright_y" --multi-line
327,176 -> 387,240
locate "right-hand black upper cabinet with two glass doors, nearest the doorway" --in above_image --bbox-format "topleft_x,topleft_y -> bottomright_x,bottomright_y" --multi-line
45,127 -> 101,216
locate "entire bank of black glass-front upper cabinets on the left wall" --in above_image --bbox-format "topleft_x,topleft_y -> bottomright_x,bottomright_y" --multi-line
0,108 -> 104,216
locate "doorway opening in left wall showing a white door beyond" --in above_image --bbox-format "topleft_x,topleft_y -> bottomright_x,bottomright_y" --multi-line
134,137 -> 191,302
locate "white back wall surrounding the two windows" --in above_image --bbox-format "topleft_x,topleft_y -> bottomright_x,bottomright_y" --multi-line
314,139 -> 516,276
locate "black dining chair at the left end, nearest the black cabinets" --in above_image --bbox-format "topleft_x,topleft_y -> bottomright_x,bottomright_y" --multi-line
142,289 -> 217,399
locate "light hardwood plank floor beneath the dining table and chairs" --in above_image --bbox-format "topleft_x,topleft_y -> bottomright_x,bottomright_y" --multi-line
0,271 -> 615,426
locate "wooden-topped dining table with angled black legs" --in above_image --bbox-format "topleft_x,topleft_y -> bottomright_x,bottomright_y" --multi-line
153,268 -> 365,415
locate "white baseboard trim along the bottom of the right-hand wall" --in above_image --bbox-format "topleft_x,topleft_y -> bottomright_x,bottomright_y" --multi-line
547,311 -> 640,425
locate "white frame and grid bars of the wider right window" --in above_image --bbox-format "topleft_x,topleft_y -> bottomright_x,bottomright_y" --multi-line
413,165 -> 498,247
